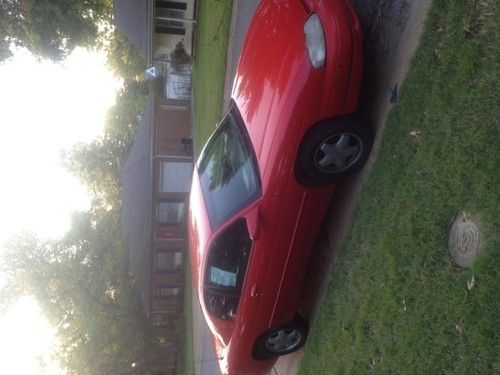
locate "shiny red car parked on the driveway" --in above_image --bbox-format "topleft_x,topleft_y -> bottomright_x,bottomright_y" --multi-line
189,0 -> 372,375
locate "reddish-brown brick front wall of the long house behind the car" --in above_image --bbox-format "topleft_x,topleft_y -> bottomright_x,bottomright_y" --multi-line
149,98 -> 193,314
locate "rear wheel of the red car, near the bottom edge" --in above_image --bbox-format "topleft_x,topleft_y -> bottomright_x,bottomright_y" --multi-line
253,316 -> 308,360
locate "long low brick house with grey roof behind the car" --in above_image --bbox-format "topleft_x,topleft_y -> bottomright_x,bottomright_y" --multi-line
122,98 -> 193,315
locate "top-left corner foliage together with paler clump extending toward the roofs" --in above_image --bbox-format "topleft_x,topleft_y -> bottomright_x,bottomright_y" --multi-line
0,0 -> 146,80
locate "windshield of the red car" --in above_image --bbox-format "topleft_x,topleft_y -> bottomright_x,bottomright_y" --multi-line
198,105 -> 261,229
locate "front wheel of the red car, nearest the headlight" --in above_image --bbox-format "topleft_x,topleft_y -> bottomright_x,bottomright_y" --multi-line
295,116 -> 373,186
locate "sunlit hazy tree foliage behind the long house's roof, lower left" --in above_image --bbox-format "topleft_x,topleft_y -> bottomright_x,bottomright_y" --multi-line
1,64 -> 151,374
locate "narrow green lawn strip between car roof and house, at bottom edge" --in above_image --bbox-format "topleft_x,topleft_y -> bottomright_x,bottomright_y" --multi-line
181,261 -> 194,375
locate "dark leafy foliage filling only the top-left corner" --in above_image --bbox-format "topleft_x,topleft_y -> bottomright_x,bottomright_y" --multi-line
0,0 -> 113,61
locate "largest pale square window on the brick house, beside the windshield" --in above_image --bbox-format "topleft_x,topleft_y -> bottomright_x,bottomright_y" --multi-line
160,161 -> 193,193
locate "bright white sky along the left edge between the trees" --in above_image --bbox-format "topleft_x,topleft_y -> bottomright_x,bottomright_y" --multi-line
0,49 -> 120,374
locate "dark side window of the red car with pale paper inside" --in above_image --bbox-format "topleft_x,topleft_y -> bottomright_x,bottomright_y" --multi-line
204,219 -> 252,320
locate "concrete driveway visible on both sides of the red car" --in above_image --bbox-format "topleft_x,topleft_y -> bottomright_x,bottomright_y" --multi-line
197,0 -> 431,375
